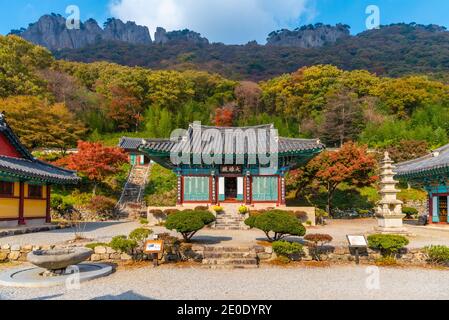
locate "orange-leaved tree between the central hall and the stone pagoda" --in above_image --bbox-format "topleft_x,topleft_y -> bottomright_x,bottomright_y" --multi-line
290,142 -> 378,214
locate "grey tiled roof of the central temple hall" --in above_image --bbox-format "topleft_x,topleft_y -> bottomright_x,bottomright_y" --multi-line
135,125 -> 325,154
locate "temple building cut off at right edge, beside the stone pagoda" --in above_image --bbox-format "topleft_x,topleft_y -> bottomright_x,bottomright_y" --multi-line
396,144 -> 449,224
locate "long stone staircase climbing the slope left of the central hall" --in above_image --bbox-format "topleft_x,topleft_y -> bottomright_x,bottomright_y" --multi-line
117,165 -> 151,219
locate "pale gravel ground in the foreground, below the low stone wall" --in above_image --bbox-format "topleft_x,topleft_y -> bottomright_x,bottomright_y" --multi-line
0,266 -> 449,300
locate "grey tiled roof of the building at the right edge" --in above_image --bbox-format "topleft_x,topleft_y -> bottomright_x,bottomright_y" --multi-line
396,144 -> 449,178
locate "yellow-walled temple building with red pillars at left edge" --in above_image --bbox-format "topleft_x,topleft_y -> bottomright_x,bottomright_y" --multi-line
0,114 -> 79,227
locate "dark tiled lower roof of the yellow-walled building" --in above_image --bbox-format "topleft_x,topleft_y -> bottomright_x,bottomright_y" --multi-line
0,156 -> 80,184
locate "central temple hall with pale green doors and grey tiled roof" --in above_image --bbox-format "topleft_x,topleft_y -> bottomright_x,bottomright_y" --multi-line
120,124 -> 325,206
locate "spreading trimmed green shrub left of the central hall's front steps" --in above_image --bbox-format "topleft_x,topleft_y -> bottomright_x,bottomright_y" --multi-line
165,210 -> 215,242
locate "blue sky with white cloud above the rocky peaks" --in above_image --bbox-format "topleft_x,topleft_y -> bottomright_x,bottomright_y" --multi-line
0,0 -> 449,43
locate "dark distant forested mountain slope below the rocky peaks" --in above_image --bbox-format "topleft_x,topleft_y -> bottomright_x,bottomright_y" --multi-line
55,24 -> 449,82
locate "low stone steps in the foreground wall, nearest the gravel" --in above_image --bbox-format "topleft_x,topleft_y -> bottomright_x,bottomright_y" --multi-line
203,246 -> 259,269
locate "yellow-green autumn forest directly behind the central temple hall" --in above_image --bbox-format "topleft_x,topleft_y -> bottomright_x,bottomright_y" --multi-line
0,36 -> 449,155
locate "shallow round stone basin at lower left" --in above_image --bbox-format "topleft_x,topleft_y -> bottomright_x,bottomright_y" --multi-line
27,248 -> 94,270
